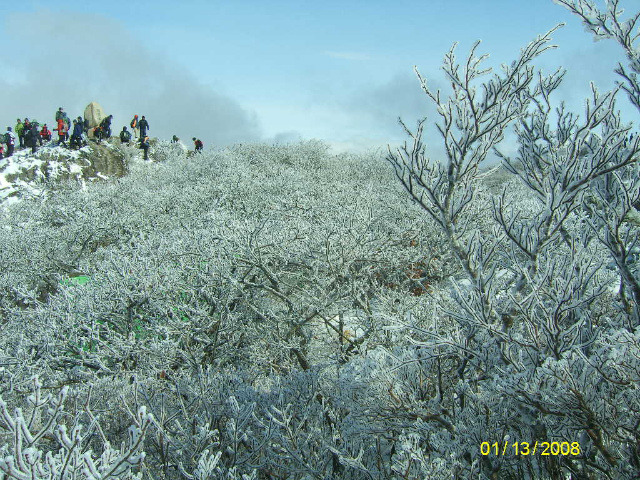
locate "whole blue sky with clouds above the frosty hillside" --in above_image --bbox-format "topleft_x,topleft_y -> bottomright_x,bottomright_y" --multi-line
0,0 -> 637,151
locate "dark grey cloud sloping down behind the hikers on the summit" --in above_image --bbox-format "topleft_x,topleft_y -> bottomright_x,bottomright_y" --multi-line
0,11 -> 261,146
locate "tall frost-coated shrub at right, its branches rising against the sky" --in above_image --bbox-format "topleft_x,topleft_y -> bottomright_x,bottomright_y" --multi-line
387,1 -> 640,479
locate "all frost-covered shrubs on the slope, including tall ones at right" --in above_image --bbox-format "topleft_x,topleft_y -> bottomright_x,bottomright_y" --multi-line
0,0 -> 640,480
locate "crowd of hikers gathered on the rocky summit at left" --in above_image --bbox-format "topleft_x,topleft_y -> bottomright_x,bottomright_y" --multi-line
0,107 -> 204,160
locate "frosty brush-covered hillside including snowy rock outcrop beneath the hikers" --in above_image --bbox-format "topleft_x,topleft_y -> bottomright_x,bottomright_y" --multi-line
0,136 -> 640,480
